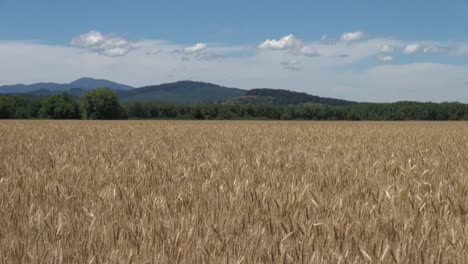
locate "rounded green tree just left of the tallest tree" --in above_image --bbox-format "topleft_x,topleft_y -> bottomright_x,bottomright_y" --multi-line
39,93 -> 80,119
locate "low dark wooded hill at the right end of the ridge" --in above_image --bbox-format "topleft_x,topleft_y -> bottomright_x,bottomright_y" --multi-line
228,89 -> 357,106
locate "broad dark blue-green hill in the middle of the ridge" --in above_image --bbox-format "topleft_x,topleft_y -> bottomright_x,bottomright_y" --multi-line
118,81 -> 247,104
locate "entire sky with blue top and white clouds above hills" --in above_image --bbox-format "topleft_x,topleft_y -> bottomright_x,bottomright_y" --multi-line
0,0 -> 468,102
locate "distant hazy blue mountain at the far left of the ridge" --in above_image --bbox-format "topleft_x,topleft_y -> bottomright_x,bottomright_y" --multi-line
0,78 -> 133,95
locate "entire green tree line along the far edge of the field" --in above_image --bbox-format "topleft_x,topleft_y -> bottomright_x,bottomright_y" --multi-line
0,88 -> 468,121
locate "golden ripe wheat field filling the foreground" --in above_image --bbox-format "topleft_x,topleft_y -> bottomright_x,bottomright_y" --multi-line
0,121 -> 468,264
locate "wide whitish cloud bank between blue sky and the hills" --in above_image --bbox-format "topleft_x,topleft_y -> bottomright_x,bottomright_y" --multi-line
0,31 -> 468,102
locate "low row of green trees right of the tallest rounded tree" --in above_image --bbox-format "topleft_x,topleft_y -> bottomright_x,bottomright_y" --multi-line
124,102 -> 468,121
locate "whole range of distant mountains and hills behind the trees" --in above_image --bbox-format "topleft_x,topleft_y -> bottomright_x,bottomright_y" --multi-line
0,78 -> 357,106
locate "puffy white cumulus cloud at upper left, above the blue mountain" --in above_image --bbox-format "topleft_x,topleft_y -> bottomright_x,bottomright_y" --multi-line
70,30 -> 132,57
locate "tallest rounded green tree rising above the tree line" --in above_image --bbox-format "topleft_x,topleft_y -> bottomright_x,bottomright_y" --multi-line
81,88 -> 122,120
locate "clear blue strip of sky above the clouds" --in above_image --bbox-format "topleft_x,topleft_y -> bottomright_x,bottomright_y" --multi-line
0,0 -> 468,44
